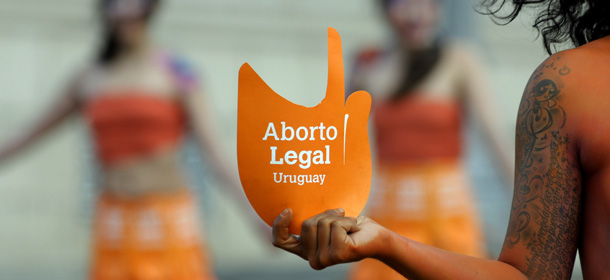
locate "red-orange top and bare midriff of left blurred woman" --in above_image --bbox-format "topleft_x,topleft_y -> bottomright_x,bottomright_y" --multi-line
85,92 -> 187,197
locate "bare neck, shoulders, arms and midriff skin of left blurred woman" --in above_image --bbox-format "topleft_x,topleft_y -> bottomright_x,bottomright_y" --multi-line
0,8 -> 245,206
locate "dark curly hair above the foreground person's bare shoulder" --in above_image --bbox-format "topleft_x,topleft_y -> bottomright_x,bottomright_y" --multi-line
477,0 -> 610,54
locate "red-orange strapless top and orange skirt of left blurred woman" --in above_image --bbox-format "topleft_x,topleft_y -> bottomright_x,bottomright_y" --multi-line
85,92 -> 214,280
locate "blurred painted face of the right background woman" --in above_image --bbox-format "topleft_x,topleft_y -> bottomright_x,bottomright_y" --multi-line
387,0 -> 441,48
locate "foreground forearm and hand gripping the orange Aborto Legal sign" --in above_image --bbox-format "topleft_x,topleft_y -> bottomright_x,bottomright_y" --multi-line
273,209 -> 525,280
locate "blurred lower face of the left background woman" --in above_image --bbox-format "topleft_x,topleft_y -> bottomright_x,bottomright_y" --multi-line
104,0 -> 149,45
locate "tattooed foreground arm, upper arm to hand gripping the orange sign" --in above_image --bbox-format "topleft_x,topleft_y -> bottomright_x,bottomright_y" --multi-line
273,54 -> 582,279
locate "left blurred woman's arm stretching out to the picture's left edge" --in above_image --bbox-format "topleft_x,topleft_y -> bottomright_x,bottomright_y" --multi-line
0,76 -> 79,165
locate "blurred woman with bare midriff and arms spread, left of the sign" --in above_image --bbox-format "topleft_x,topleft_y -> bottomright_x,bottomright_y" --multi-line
0,0 -> 239,280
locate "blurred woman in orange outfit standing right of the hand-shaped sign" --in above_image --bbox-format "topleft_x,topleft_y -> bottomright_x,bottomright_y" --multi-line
351,0 -> 512,279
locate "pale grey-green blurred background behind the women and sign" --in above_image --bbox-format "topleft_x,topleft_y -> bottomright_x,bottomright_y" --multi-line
0,0 -> 580,280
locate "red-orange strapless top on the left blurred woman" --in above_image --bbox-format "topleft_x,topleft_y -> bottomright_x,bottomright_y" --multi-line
85,93 -> 186,165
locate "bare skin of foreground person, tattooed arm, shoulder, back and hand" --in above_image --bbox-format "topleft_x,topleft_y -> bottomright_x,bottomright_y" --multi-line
273,37 -> 610,279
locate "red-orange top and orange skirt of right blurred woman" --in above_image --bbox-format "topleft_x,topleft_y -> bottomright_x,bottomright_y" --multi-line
350,96 -> 485,280
